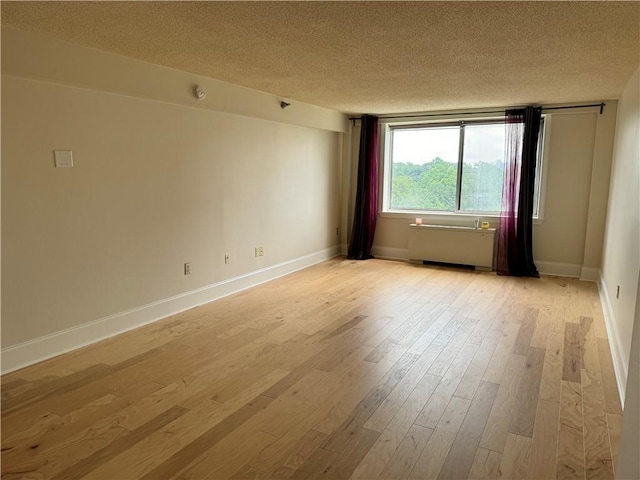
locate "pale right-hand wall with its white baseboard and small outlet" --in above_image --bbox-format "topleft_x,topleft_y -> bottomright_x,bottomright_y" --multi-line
601,66 -> 640,402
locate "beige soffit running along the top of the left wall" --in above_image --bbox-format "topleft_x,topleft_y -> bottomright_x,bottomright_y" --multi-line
1,26 -> 348,132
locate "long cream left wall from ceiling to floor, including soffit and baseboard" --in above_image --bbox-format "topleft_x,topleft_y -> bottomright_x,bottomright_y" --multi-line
1,29 -> 347,371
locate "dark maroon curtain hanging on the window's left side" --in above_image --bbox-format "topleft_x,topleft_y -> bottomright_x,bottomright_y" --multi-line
347,115 -> 378,260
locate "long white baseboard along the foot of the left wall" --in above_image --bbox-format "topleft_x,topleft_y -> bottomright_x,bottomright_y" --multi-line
1,246 -> 341,374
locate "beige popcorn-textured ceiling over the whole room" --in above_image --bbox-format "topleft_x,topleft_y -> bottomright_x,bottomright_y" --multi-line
2,1 -> 640,113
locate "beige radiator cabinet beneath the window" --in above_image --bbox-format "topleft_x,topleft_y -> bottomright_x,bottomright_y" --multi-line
409,225 -> 496,270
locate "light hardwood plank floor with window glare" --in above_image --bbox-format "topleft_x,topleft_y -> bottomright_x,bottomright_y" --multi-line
2,258 -> 622,479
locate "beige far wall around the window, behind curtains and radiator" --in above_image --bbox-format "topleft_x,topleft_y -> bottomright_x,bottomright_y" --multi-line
345,107 -> 617,280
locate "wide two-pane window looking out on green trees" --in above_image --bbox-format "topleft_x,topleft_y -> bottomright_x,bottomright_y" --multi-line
383,119 -> 544,217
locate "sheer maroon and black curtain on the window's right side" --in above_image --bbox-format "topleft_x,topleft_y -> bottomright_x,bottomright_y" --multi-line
497,107 -> 542,277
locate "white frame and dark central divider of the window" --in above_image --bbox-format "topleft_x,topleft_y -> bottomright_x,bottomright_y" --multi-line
379,114 -> 551,224
